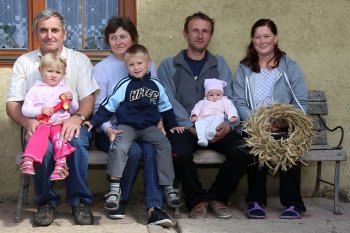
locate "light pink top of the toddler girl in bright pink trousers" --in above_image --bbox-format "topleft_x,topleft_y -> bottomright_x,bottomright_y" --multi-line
22,80 -> 79,123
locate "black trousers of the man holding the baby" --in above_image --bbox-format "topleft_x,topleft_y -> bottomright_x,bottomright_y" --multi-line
169,131 -> 250,210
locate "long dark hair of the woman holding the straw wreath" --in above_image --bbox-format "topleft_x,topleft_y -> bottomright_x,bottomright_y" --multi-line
241,19 -> 286,73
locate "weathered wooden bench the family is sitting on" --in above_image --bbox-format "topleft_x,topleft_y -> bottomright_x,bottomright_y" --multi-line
15,91 -> 347,222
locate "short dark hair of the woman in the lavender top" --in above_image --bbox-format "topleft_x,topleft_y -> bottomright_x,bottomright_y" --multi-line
105,16 -> 139,46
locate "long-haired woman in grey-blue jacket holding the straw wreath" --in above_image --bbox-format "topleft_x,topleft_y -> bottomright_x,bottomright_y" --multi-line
233,19 -> 307,219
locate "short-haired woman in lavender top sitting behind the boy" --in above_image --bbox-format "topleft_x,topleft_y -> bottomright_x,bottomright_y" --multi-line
94,16 -> 172,227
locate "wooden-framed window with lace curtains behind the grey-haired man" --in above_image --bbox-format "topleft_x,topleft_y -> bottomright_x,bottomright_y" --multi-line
0,0 -> 136,67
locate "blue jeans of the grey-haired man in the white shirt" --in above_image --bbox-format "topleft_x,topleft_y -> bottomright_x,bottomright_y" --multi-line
34,126 -> 92,206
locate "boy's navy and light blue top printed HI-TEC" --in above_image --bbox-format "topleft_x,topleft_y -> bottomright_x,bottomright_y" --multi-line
90,72 -> 178,130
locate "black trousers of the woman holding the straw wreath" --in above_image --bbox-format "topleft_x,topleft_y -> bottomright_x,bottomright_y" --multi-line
246,156 -> 306,211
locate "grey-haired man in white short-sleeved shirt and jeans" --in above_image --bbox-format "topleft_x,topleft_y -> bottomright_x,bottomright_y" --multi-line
6,9 -> 98,226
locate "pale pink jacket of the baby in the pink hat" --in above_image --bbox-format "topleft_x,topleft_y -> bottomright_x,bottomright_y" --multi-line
191,96 -> 238,119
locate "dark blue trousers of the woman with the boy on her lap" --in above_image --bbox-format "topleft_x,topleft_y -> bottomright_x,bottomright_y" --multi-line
95,132 -> 163,209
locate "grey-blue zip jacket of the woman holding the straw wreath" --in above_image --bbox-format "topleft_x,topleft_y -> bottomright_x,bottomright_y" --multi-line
233,55 -> 307,133
